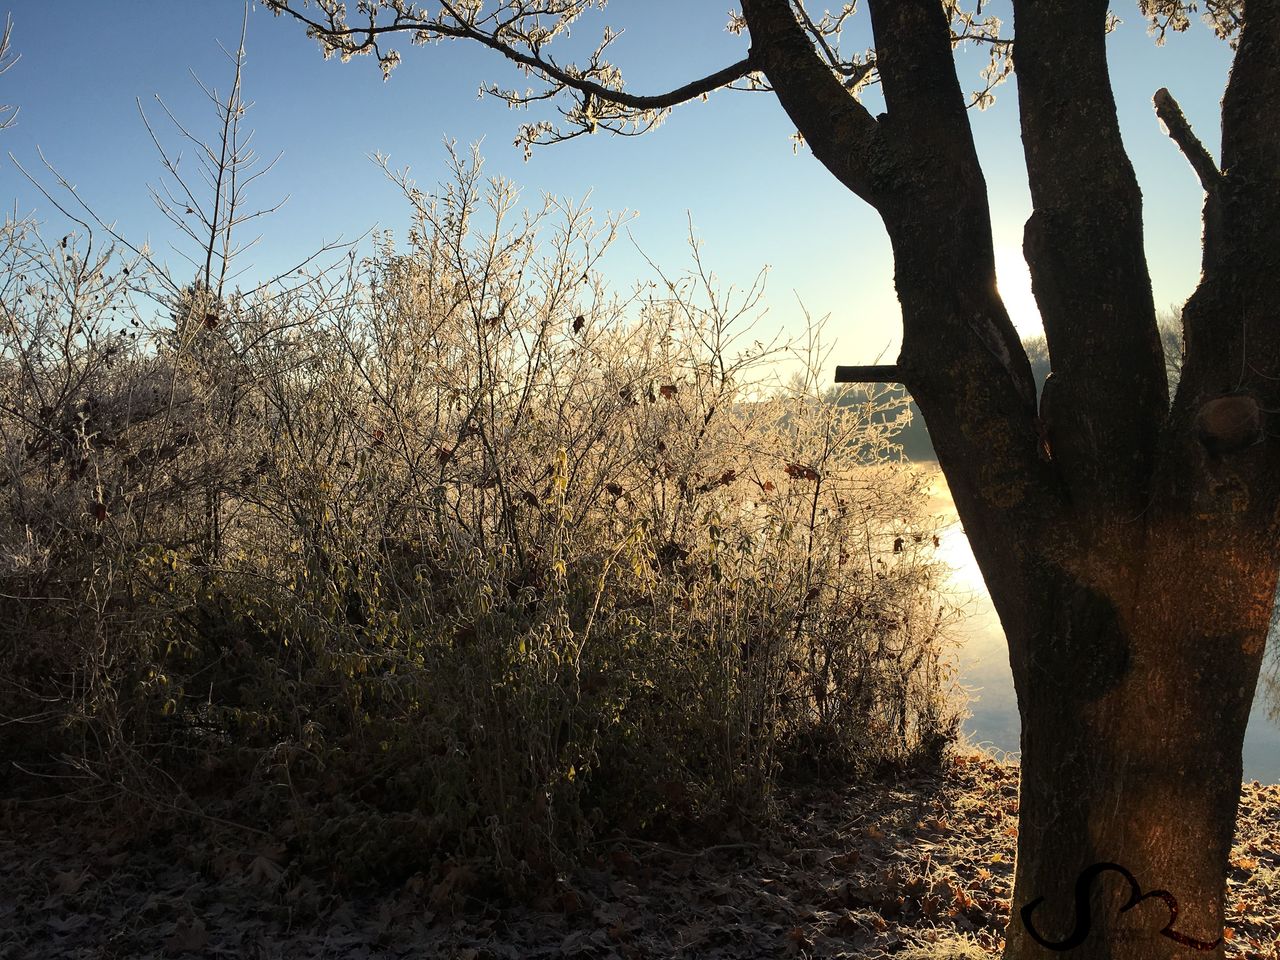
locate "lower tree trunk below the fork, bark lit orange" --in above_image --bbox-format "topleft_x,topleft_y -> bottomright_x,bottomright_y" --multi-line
988,535 -> 1275,960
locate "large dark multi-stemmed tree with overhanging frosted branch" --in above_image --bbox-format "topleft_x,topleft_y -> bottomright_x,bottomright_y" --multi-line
268,0 -> 1280,960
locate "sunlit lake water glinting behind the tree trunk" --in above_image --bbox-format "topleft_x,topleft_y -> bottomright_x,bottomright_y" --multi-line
929,475 -> 1280,783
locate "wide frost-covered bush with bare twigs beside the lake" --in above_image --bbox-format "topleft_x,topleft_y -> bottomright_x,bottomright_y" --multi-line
0,146 -> 957,883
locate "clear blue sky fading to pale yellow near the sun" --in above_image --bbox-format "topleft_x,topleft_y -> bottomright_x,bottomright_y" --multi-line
0,0 -> 1230,364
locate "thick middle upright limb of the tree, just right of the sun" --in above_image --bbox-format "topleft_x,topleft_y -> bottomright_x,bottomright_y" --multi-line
1014,0 -> 1169,530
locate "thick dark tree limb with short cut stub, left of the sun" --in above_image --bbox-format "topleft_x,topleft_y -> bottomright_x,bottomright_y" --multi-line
819,0 -> 1060,583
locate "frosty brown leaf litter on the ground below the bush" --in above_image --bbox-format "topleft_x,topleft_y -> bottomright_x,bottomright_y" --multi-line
0,754 -> 1280,960
